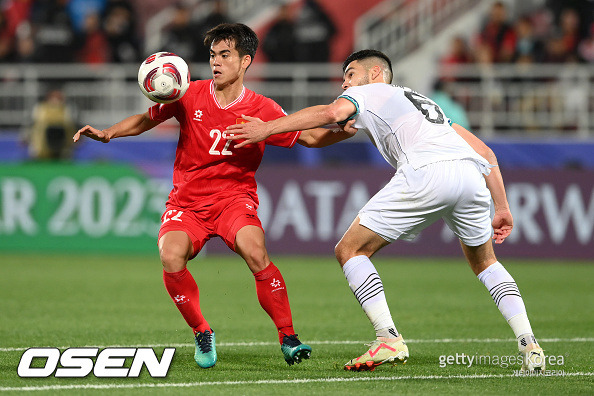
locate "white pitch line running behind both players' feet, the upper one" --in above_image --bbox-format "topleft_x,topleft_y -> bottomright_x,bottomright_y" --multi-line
0,337 -> 594,352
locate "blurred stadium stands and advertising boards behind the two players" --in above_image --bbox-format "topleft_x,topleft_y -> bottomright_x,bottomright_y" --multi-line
0,0 -> 594,258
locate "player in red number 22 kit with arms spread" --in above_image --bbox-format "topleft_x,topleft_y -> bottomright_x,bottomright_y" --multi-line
74,24 -> 351,368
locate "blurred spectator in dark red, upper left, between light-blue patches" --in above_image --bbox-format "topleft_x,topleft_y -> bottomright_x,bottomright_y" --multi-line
77,12 -> 111,64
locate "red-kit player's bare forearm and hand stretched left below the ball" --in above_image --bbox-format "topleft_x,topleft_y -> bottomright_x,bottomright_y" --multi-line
72,112 -> 161,143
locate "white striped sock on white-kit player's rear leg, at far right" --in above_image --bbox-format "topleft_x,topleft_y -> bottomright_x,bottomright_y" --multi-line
478,261 -> 536,343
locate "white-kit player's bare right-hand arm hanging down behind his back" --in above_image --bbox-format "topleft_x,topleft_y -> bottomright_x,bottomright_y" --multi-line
452,124 -> 514,243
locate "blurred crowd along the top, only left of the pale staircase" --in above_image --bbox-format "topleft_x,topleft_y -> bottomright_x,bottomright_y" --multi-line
0,0 -> 336,64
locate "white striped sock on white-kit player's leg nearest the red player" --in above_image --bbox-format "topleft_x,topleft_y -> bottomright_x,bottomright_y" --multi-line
342,256 -> 398,338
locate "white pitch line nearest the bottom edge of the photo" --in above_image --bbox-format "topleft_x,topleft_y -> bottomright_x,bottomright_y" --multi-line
0,372 -> 594,392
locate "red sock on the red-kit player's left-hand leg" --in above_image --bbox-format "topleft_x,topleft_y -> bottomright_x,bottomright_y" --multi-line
163,268 -> 210,333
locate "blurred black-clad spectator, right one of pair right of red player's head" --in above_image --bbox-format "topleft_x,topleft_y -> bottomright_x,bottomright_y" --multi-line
295,0 -> 336,62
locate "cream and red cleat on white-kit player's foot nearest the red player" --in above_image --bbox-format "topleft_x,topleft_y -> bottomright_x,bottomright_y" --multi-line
344,336 -> 408,371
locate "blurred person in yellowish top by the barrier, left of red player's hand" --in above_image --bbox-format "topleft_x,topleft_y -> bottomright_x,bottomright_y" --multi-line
23,89 -> 77,160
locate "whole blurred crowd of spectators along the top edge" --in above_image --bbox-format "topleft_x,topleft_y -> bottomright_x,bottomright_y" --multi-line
0,0 -> 594,65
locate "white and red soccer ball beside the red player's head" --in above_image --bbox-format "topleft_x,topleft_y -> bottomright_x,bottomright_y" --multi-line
138,52 -> 190,103
